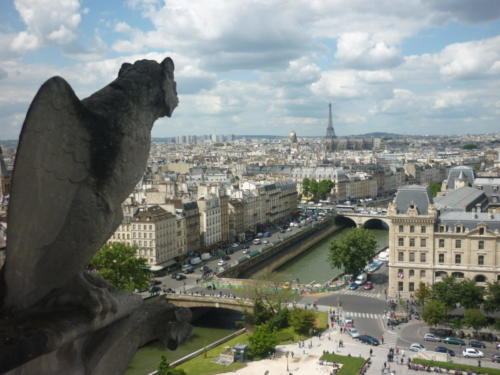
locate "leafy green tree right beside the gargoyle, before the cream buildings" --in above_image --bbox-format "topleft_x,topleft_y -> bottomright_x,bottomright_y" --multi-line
90,242 -> 150,292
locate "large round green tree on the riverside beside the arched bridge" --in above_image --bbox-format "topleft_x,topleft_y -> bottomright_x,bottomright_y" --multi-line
329,228 -> 377,275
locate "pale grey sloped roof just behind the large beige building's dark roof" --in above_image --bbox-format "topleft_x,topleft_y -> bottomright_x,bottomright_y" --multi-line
434,186 -> 488,211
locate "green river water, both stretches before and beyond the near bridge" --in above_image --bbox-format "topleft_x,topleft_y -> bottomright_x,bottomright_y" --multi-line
126,228 -> 388,375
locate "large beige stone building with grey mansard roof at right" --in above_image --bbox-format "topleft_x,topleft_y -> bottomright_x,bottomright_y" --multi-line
388,185 -> 500,298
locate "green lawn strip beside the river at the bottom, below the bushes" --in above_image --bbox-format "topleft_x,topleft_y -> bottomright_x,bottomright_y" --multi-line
176,333 -> 248,375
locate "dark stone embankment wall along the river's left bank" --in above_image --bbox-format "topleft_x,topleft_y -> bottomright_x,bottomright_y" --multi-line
217,218 -> 343,278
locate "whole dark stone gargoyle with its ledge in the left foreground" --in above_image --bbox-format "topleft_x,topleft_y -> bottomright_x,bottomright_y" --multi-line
0,58 -> 190,375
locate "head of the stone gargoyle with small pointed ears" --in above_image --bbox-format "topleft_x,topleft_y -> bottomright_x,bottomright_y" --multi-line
117,57 -> 179,117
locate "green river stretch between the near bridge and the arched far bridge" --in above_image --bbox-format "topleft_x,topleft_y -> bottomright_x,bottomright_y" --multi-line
268,228 -> 389,284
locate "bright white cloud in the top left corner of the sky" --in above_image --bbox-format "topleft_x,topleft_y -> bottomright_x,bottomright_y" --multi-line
11,0 -> 81,51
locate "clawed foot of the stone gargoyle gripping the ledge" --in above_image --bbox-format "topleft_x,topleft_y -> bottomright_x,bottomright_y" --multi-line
44,274 -> 117,320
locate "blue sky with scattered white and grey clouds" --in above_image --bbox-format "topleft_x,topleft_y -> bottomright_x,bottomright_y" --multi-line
0,0 -> 500,139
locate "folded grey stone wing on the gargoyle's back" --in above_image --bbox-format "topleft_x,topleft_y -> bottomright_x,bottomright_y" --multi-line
6,77 -> 90,280
